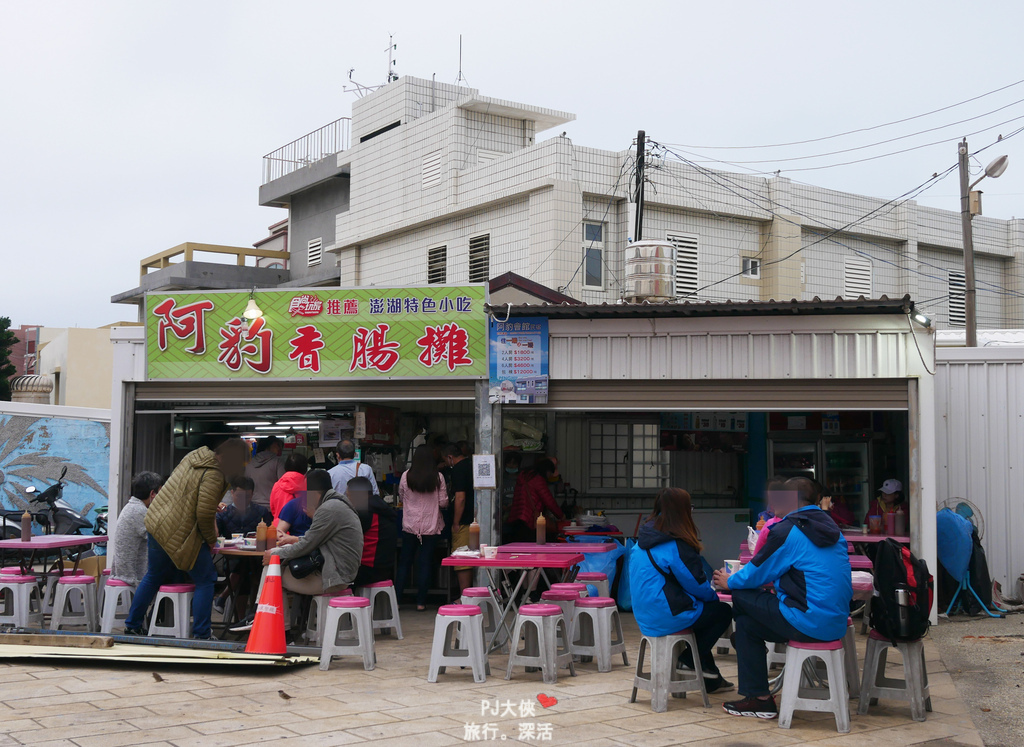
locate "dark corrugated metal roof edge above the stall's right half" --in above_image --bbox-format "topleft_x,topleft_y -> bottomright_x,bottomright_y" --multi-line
487,295 -> 913,319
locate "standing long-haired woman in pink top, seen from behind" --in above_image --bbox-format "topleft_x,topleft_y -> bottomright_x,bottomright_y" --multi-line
394,446 -> 447,611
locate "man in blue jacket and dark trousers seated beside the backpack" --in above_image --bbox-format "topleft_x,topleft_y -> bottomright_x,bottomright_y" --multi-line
715,478 -> 853,718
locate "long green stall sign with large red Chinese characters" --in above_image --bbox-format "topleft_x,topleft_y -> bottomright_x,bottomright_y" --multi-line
145,285 -> 487,380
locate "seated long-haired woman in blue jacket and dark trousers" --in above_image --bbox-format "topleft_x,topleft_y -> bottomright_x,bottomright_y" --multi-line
630,488 -> 733,693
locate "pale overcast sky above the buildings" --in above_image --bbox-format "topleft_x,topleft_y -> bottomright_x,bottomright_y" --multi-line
0,0 -> 1024,327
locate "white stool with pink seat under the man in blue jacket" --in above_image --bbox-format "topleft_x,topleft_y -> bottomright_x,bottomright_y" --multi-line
778,640 -> 850,734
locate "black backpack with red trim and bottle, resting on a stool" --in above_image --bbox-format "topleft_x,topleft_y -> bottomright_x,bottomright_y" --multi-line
871,539 -> 934,640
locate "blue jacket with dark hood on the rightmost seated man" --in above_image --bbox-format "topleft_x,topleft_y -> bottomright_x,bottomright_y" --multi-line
729,506 -> 853,640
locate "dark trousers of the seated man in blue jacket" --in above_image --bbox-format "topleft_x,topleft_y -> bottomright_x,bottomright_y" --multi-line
732,589 -> 818,698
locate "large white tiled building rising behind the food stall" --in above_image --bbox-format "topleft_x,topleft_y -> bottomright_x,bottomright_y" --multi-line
261,77 -> 1024,328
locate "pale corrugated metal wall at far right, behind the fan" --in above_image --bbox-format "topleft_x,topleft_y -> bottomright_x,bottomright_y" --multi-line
935,347 -> 1024,592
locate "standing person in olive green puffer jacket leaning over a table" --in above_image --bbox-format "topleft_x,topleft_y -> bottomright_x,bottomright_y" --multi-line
123,439 -> 249,639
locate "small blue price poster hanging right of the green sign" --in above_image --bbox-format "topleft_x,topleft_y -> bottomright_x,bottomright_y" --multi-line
489,317 -> 548,405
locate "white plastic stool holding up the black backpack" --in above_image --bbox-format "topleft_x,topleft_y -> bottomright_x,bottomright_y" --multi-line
857,629 -> 932,721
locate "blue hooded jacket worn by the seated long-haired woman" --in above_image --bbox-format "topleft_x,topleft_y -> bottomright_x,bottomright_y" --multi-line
630,523 -> 718,636
